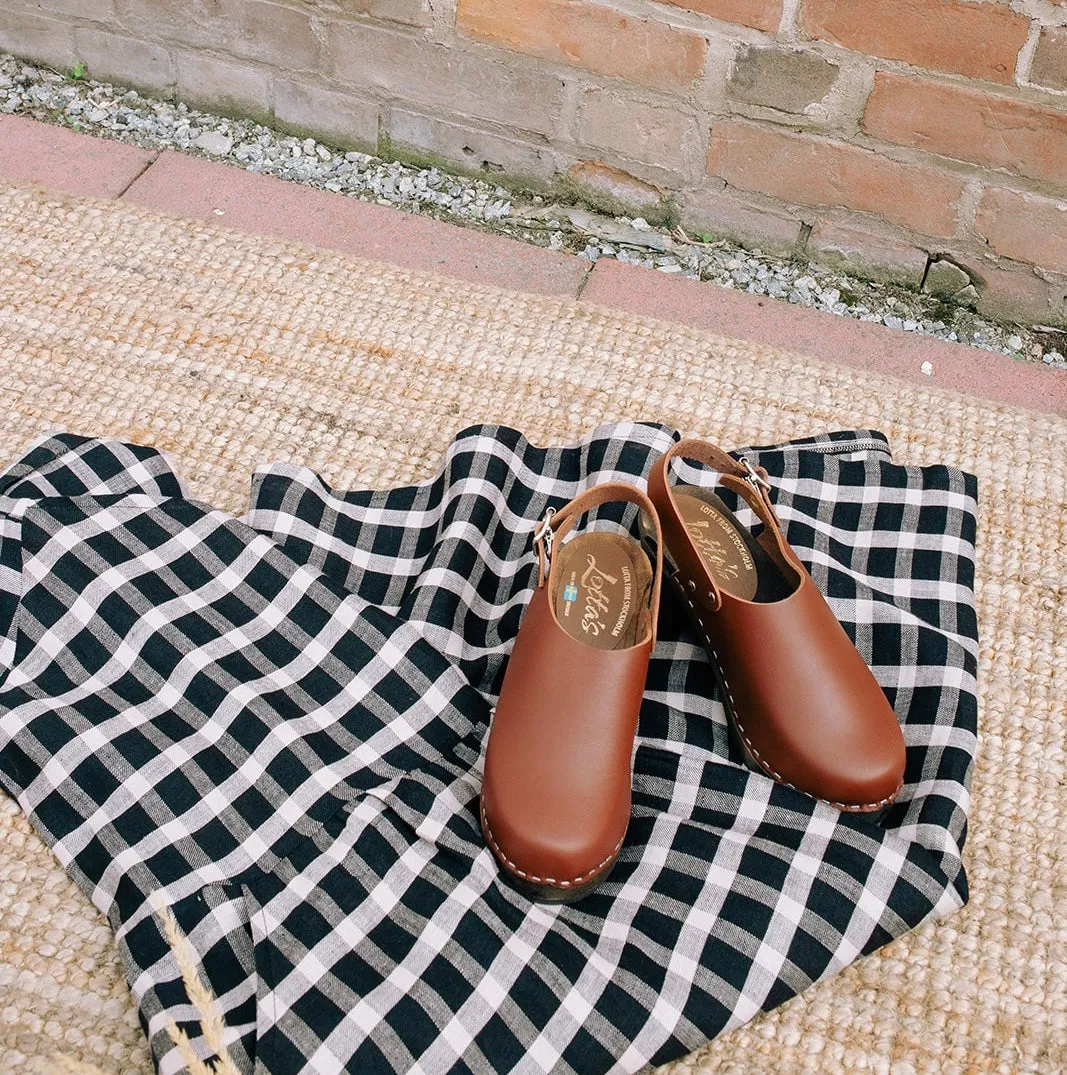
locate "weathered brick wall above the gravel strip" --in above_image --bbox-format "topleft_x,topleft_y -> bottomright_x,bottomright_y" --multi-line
0,0 -> 1067,324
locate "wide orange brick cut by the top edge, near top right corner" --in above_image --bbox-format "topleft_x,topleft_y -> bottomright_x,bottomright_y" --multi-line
799,0 -> 1029,83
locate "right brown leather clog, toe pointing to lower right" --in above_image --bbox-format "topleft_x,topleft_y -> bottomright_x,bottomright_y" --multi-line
648,440 -> 905,812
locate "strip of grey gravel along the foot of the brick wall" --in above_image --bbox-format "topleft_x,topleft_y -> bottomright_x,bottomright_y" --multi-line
0,53 -> 1067,369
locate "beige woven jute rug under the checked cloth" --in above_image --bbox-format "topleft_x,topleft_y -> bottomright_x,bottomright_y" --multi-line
0,180 -> 1067,1075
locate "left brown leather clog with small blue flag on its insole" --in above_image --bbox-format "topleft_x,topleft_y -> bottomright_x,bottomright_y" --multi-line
481,483 -> 663,903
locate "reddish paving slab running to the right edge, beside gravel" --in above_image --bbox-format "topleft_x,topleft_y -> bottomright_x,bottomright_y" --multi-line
581,259 -> 1067,414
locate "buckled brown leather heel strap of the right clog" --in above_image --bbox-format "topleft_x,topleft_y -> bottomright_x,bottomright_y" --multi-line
648,440 -> 795,612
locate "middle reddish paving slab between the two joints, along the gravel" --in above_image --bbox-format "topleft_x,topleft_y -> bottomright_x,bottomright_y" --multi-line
122,152 -> 590,296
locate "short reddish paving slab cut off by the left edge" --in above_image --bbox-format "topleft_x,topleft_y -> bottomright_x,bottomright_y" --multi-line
0,115 -> 157,198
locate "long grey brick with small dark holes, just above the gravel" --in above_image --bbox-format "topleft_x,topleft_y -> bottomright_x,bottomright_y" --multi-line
387,109 -> 556,184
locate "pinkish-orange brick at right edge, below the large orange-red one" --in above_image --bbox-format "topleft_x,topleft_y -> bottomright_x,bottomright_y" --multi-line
975,187 -> 1067,272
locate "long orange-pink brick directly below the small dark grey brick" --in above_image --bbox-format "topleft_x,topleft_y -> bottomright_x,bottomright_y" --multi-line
708,119 -> 963,235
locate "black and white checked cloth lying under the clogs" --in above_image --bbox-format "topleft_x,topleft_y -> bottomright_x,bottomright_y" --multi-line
0,425 -> 977,1075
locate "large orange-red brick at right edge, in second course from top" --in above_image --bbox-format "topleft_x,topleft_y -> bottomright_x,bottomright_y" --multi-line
863,71 -> 1067,184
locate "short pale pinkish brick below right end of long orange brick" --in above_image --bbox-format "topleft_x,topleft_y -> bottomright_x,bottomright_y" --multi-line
578,89 -> 695,171
